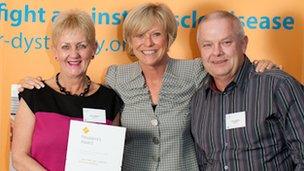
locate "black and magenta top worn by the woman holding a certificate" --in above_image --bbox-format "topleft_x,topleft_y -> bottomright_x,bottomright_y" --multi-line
19,85 -> 123,171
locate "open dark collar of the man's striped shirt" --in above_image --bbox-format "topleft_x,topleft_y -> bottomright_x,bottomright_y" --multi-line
203,56 -> 253,95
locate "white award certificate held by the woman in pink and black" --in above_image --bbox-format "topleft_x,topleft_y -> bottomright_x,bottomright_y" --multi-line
65,121 -> 126,171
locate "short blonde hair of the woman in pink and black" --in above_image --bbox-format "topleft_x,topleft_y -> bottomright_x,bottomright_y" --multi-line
52,10 -> 96,46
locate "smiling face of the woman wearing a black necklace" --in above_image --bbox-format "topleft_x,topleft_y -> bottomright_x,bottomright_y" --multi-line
53,30 -> 96,77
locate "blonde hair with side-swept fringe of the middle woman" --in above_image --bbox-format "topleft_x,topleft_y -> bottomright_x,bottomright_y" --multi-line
123,3 -> 177,55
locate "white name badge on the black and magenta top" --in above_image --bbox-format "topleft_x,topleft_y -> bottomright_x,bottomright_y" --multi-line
82,108 -> 107,123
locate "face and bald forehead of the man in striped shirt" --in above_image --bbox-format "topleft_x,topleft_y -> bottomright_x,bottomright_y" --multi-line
197,18 -> 248,81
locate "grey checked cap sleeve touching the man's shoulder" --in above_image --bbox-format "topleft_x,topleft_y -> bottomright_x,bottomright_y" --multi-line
193,58 -> 207,90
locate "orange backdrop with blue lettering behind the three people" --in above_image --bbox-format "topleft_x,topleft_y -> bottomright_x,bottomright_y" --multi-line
0,0 -> 304,170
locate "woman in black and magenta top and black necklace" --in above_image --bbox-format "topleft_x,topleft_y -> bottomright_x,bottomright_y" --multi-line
12,10 -> 122,171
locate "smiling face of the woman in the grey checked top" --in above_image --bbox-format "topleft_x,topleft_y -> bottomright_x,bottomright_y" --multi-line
130,24 -> 168,66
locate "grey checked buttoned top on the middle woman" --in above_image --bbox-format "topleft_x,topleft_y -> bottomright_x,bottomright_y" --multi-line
106,58 -> 206,171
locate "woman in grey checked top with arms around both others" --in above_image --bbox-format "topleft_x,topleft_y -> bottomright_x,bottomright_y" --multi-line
19,3 -> 280,171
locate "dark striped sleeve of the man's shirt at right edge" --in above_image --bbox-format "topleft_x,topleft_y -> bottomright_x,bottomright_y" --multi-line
275,78 -> 304,170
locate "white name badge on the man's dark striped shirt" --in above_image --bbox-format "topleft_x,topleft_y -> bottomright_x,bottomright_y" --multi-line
226,111 -> 246,130
